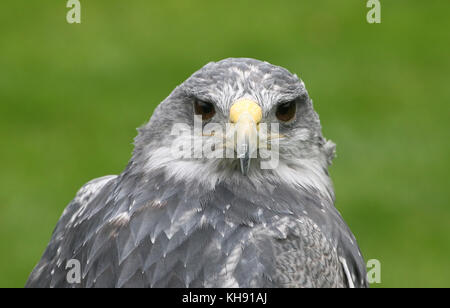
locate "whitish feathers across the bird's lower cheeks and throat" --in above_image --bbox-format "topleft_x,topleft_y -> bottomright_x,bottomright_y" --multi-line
144,133 -> 334,200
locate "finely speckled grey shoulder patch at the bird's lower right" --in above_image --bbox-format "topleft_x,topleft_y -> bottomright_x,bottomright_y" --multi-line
250,216 -> 344,288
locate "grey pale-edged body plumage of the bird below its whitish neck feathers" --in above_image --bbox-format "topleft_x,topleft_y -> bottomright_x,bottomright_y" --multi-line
27,167 -> 365,287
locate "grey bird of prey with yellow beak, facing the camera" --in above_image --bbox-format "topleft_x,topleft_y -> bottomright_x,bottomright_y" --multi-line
26,58 -> 368,288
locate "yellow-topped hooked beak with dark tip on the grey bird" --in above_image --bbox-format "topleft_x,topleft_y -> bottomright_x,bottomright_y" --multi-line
230,99 -> 262,175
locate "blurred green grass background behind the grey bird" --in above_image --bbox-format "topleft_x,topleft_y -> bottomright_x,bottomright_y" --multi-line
0,0 -> 450,287
